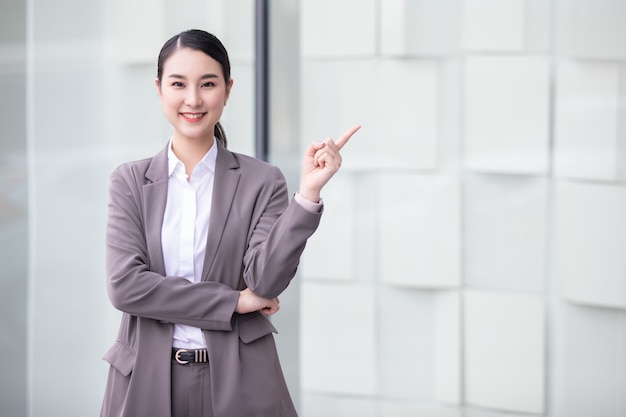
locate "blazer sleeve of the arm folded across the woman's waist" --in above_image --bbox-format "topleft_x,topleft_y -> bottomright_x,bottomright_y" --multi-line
106,166 -> 239,330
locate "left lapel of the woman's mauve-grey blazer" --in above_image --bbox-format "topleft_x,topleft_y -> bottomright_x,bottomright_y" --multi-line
143,146 -> 168,275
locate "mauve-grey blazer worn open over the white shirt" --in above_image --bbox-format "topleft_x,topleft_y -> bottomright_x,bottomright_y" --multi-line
101,141 -> 321,417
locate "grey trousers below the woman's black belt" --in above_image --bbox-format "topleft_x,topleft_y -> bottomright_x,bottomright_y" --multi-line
172,360 -> 213,417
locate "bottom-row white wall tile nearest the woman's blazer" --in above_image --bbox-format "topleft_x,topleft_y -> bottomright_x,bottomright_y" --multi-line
300,282 -> 378,396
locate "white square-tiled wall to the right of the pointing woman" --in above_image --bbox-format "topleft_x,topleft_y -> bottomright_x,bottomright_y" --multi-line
300,0 -> 626,417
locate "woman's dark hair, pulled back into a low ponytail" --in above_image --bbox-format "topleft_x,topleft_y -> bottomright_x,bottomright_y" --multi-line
157,29 -> 230,147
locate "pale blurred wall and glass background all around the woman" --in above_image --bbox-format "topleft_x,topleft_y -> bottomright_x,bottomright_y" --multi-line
0,0 -> 626,417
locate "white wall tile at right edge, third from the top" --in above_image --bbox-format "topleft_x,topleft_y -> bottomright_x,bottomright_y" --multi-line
556,181 -> 626,309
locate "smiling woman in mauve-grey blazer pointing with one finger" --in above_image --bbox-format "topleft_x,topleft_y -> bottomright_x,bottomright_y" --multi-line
101,30 -> 359,417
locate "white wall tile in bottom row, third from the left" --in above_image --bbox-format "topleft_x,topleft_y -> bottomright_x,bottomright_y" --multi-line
463,290 -> 545,414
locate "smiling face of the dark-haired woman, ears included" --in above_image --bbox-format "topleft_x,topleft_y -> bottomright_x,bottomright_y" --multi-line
156,48 -> 233,141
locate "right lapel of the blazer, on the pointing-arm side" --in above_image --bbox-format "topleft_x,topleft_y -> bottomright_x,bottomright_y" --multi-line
202,143 -> 241,281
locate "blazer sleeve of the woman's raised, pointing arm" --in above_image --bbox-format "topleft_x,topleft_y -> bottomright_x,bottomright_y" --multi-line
243,167 -> 322,298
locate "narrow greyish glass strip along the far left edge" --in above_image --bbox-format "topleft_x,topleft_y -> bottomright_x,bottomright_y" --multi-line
0,1 -> 29,417
